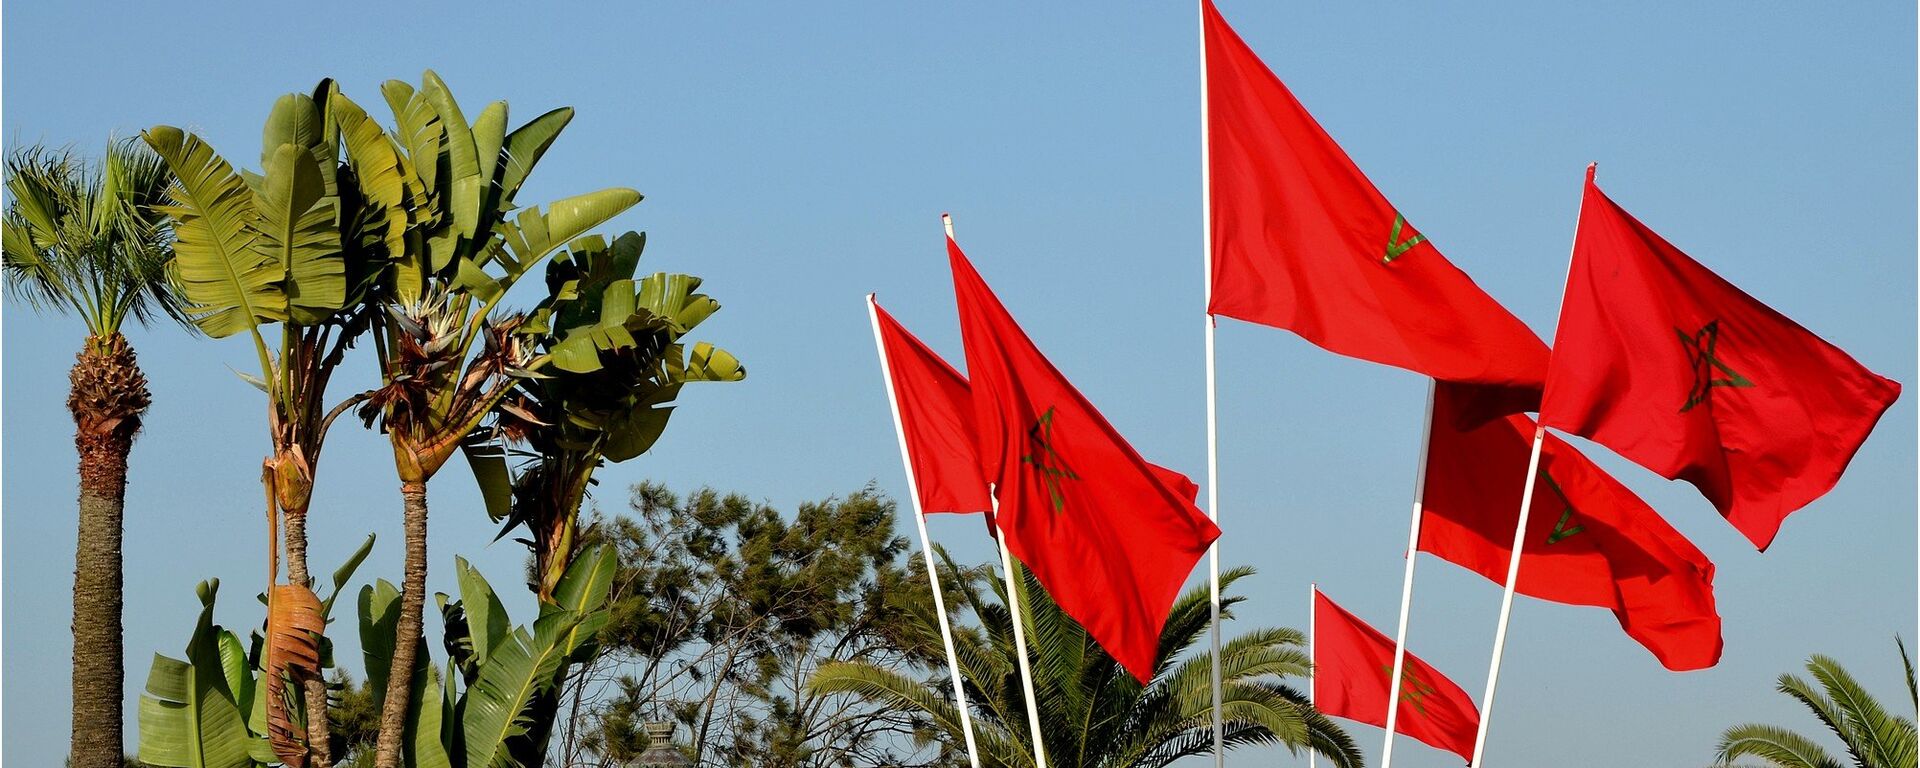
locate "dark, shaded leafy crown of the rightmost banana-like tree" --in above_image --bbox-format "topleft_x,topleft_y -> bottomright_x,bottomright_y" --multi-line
482,232 -> 747,599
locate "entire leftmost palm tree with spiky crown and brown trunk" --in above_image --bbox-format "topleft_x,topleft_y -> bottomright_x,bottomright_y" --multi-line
4,142 -> 180,768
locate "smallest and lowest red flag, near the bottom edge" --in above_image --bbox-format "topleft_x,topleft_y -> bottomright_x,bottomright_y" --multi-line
1309,589 -> 1480,760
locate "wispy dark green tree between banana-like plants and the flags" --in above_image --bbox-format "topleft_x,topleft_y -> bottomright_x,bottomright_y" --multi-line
559,484 -> 952,768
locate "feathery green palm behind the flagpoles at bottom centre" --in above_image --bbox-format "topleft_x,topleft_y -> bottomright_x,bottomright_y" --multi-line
810,551 -> 1361,768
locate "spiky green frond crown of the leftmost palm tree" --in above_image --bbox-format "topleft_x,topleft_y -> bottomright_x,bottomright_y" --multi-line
0,140 -> 182,338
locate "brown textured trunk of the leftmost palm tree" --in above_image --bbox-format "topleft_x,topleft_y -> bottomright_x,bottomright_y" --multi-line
67,334 -> 150,768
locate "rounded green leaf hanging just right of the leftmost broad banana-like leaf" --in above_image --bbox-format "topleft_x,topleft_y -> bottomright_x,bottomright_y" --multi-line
253,144 -> 348,324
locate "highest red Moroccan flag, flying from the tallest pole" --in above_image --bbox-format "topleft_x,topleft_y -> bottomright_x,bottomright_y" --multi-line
1202,2 -> 1548,413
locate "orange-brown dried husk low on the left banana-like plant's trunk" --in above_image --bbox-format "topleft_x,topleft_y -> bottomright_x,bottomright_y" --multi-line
261,584 -> 326,768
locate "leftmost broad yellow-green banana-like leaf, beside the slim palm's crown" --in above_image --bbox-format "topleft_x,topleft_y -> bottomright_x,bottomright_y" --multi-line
140,125 -> 288,338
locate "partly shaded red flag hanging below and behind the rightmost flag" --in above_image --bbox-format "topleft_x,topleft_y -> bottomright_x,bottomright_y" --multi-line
1421,384 -> 1720,672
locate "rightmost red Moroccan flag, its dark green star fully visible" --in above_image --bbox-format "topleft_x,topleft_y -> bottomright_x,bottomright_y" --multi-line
1540,169 -> 1901,551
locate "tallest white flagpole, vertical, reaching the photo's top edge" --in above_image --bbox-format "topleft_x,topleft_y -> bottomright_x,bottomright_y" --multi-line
1194,0 -> 1227,768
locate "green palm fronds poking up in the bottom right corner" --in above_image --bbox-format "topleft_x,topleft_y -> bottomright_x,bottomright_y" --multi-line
1720,637 -> 1920,768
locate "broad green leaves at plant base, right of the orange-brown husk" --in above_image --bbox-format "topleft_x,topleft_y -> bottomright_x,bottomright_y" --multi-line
355,545 -> 614,768
